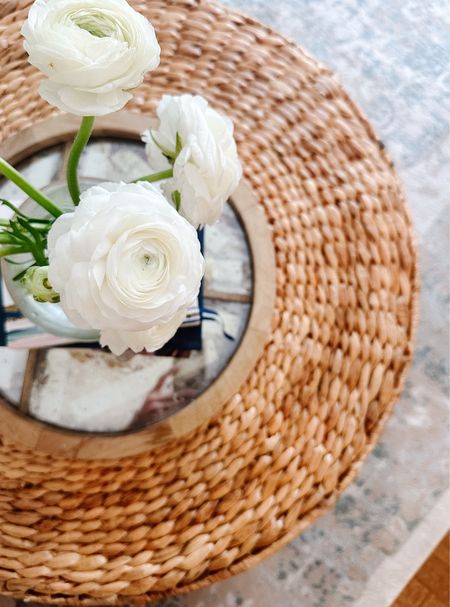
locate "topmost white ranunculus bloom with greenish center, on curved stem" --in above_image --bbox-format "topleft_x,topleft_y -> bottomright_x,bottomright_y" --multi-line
22,0 -> 160,116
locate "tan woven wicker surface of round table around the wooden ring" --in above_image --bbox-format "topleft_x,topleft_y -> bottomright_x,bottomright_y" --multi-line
0,0 -> 417,604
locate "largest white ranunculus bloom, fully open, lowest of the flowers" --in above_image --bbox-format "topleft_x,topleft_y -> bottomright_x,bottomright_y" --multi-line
48,182 -> 204,354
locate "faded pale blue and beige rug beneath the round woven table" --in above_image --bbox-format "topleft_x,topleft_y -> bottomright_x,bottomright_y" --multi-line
149,0 -> 450,607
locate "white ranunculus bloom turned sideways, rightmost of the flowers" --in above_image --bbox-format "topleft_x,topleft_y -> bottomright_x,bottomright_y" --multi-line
143,95 -> 242,227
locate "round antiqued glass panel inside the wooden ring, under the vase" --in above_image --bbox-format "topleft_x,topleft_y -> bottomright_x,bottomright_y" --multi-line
0,139 -> 253,433
